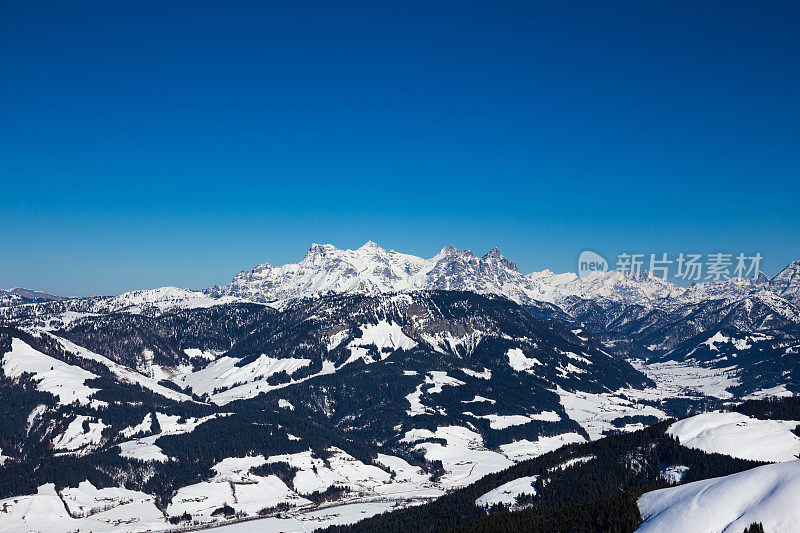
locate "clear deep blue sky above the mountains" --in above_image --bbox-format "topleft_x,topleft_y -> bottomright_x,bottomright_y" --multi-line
0,0 -> 800,295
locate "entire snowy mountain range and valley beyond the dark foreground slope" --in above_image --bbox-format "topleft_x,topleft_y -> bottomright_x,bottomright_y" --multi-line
0,242 -> 800,531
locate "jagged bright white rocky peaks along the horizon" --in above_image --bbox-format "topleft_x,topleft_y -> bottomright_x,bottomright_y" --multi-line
208,241 -> 800,307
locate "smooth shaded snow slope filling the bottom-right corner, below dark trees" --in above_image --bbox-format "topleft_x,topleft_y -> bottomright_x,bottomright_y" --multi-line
637,461 -> 800,533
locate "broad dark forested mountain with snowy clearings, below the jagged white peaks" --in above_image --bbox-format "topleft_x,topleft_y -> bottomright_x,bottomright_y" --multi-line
0,291 -> 667,530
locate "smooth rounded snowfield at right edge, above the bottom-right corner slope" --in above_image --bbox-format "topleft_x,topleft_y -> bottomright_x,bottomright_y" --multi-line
667,411 -> 800,462
